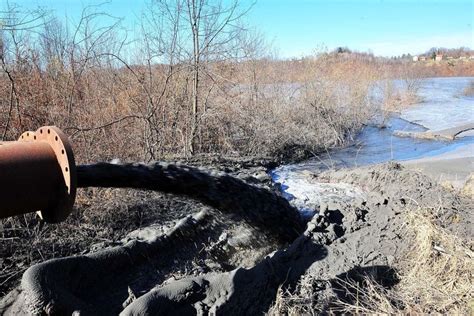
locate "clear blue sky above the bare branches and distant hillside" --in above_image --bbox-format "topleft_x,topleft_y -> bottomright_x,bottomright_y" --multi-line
2,0 -> 474,58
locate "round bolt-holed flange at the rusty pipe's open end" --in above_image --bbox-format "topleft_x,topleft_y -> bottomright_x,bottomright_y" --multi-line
19,126 -> 77,223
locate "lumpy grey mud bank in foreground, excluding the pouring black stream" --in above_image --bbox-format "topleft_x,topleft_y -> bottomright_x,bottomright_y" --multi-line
0,164 -> 473,315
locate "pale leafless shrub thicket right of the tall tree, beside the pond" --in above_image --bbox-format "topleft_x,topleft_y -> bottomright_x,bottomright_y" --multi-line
202,57 -> 377,155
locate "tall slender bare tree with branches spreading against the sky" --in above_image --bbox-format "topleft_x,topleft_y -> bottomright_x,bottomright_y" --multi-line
148,0 -> 254,154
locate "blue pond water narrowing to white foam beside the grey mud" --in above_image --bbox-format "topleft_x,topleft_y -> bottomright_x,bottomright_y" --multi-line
271,78 -> 474,215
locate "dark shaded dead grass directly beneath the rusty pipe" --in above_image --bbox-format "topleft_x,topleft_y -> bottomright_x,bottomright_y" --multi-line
0,189 -> 192,297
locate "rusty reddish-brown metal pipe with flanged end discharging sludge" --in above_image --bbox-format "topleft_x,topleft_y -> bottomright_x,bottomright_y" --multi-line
0,126 -> 76,223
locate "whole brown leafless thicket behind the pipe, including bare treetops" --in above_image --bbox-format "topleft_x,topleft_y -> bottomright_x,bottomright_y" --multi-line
0,0 -> 378,162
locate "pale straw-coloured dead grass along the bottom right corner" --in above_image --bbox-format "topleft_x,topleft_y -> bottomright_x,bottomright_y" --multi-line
269,210 -> 474,315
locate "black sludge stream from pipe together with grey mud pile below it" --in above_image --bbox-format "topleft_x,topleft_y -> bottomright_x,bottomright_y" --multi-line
0,164 -> 470,315
